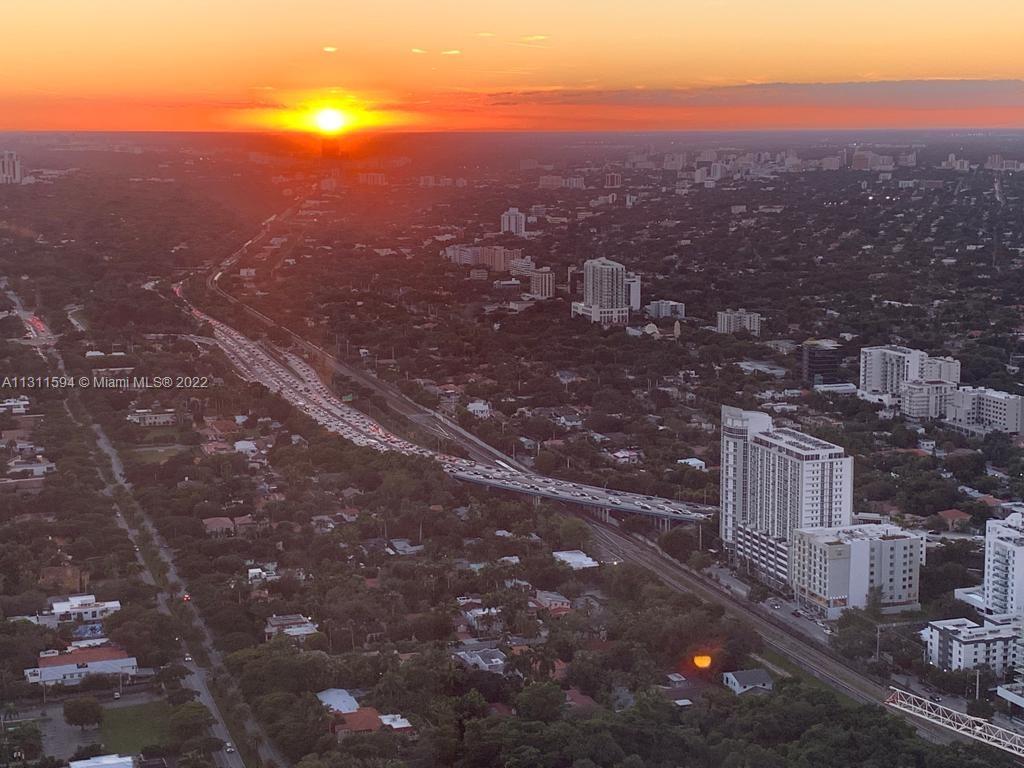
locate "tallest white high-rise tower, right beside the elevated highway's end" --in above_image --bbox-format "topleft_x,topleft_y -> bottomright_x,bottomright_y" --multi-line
721,406 -> 853,586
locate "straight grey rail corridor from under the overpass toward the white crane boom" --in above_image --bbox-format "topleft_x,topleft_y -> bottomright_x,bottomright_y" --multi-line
587,520 -> 958,743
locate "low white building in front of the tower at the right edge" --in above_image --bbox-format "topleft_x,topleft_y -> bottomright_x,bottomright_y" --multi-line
922,616 -> 1021,677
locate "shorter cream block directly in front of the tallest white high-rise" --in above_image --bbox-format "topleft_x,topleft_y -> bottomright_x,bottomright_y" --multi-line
790,524 -> 925,621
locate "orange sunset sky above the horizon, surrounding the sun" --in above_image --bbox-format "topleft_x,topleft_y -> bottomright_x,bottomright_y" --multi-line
6,0 -> 1024,131
